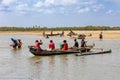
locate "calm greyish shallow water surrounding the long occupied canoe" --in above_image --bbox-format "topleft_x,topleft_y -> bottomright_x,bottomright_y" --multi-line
0,35 -> 120,80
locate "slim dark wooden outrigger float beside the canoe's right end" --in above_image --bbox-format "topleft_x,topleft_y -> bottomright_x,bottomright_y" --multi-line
76,49 -> 112,56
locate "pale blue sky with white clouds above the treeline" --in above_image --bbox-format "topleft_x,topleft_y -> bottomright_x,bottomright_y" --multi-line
0,0 -> 120,27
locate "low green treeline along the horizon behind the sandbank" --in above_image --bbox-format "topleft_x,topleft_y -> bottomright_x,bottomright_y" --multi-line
0,26 -> 120,31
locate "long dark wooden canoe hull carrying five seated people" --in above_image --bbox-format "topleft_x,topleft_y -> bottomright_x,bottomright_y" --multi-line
28,47 -> 91,56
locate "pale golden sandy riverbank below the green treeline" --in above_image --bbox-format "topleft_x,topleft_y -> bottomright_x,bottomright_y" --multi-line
0,30 -> 120,39
